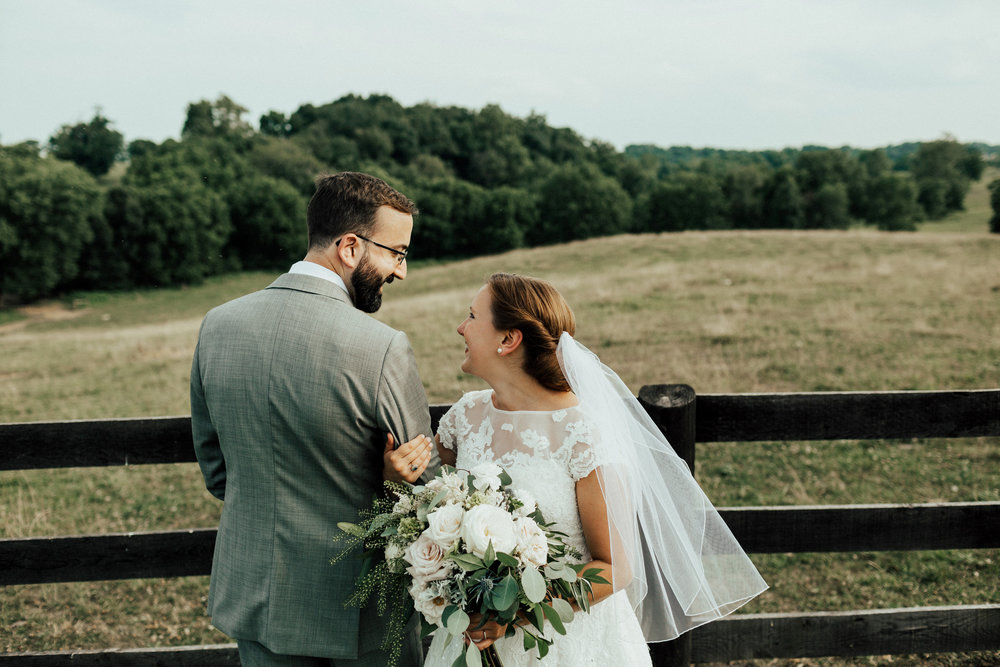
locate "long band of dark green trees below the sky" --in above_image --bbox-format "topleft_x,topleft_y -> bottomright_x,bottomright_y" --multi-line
0,95 -> 1000,303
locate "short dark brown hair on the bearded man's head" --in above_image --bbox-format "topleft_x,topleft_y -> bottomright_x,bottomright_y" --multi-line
306,171 -> 417,250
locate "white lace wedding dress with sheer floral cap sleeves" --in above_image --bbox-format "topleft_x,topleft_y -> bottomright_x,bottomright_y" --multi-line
424,390 -> 651,667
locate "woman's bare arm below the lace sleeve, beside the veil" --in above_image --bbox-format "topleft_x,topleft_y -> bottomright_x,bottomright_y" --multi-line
574,468 -> 632,606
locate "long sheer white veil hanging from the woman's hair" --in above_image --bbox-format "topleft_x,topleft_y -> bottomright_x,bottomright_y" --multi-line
556,332 -> 767,642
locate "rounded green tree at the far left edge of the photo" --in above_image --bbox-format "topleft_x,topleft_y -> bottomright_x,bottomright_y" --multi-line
0,148 -> 102,304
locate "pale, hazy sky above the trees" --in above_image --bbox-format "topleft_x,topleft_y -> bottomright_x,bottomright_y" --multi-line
0,0 -> 1000,150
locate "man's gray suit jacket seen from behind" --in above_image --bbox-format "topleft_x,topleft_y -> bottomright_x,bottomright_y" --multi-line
191,274 -> 431,658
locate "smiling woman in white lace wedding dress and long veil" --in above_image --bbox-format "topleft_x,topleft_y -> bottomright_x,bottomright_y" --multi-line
425,273 -> 767,667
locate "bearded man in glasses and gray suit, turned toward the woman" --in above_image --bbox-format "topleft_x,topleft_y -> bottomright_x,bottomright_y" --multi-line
191,172 -> 432,667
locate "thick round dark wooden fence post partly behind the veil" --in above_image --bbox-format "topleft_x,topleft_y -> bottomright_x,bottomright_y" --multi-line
639,384 -> 695,667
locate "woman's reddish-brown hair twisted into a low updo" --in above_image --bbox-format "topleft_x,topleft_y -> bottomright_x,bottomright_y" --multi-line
486,273 -> 576,391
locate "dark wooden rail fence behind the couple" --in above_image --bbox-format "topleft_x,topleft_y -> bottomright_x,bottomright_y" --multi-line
0,385 -> 1000,667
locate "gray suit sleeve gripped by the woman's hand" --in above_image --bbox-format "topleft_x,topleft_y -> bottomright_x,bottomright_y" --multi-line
375,331 -> 441,479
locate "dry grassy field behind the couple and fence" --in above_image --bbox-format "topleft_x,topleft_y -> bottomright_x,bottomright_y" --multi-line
0,197 -> 1000,665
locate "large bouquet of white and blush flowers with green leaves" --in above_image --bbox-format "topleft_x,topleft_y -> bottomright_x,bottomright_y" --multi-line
331,463 -> 607,666
